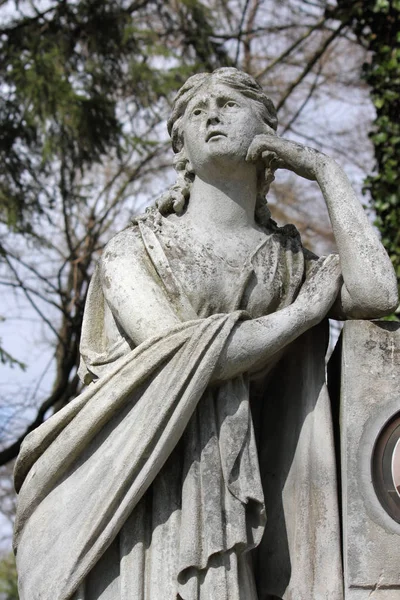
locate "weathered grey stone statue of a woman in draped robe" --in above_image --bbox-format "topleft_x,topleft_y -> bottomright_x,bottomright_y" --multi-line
15,68 -> 397,600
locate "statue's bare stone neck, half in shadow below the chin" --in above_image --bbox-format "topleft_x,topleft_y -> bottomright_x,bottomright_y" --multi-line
184,176 -> 257,231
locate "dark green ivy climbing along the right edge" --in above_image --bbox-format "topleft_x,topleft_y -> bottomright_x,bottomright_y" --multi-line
339,0 -> 400,314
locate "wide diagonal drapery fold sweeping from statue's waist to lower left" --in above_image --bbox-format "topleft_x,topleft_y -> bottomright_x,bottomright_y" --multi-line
15,312 -> 256,600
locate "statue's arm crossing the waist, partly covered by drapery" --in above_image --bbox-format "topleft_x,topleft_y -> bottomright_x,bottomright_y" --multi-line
101,230 -> 341,381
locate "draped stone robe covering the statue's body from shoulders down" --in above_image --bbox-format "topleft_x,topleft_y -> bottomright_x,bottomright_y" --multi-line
15,211 -> 342,600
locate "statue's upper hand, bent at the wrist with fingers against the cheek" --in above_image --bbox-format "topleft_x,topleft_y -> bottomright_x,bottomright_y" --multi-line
246,134 -> 332,180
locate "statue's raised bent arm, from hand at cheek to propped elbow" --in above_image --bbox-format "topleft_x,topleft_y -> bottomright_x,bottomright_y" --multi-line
248,135 -> 398,319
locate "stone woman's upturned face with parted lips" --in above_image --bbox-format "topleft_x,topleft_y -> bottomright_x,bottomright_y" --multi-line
183,83 -> 272,176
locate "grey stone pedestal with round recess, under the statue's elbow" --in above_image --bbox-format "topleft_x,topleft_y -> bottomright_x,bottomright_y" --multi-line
339,321 -> 400,600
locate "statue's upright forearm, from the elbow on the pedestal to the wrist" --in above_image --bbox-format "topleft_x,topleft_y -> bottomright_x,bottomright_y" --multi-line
317,157 -> 398,318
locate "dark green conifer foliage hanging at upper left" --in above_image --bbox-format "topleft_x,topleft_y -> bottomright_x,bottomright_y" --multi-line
0,0 -> 228,231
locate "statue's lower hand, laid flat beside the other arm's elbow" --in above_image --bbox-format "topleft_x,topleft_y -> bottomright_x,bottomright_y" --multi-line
295,254 -> 343,323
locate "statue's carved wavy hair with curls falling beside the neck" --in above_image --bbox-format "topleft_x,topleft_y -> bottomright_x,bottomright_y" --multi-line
157,67 -> 278,226
